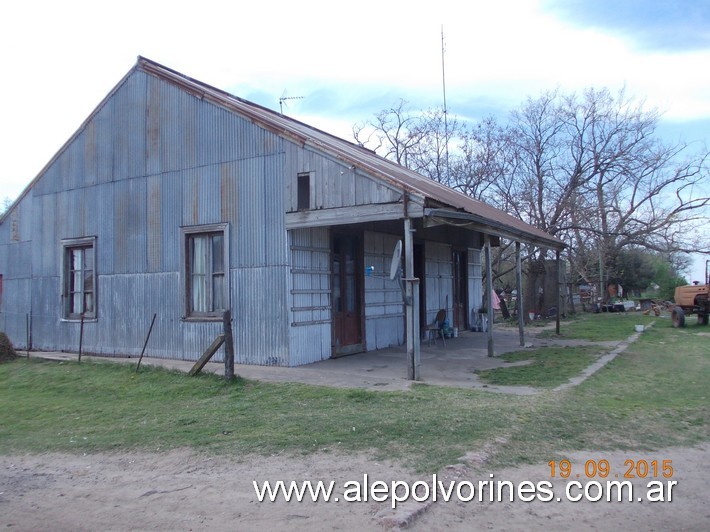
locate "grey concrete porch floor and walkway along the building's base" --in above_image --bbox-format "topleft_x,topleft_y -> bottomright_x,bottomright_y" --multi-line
27,328 -> 620,395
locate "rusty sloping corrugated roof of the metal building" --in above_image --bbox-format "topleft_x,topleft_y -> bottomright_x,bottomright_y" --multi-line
136,57 -> 565,249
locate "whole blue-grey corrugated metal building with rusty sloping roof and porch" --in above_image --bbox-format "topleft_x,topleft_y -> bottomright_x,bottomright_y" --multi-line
0,58 -> 562,366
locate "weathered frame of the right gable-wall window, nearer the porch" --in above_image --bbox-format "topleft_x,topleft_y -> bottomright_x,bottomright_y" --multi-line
180,223 -> 230,321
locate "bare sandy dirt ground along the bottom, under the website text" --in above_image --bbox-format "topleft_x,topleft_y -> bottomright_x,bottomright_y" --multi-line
0,445 -> 710,531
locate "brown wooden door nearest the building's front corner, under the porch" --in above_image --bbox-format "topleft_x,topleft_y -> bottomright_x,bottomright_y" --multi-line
331,233 -> 365,357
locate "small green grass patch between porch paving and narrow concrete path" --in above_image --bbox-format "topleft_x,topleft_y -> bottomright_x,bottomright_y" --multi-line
475,346 -> 605,388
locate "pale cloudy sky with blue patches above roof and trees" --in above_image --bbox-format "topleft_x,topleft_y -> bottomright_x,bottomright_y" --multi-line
0,0 -> 710,278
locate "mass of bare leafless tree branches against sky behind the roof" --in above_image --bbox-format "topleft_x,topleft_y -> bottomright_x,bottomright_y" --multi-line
354,88 -> 710,296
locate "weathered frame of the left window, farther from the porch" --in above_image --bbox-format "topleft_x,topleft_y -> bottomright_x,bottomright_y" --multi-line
59,236 -> 99,321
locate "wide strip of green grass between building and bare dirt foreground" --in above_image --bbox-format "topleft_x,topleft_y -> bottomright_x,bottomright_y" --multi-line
0,317 -> 710,472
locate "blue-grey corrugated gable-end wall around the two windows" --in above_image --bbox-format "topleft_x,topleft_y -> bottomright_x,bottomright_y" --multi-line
0,71 -> 290,365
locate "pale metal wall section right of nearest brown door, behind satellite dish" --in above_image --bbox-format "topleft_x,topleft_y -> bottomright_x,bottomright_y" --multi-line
365,232 -> 405,350
